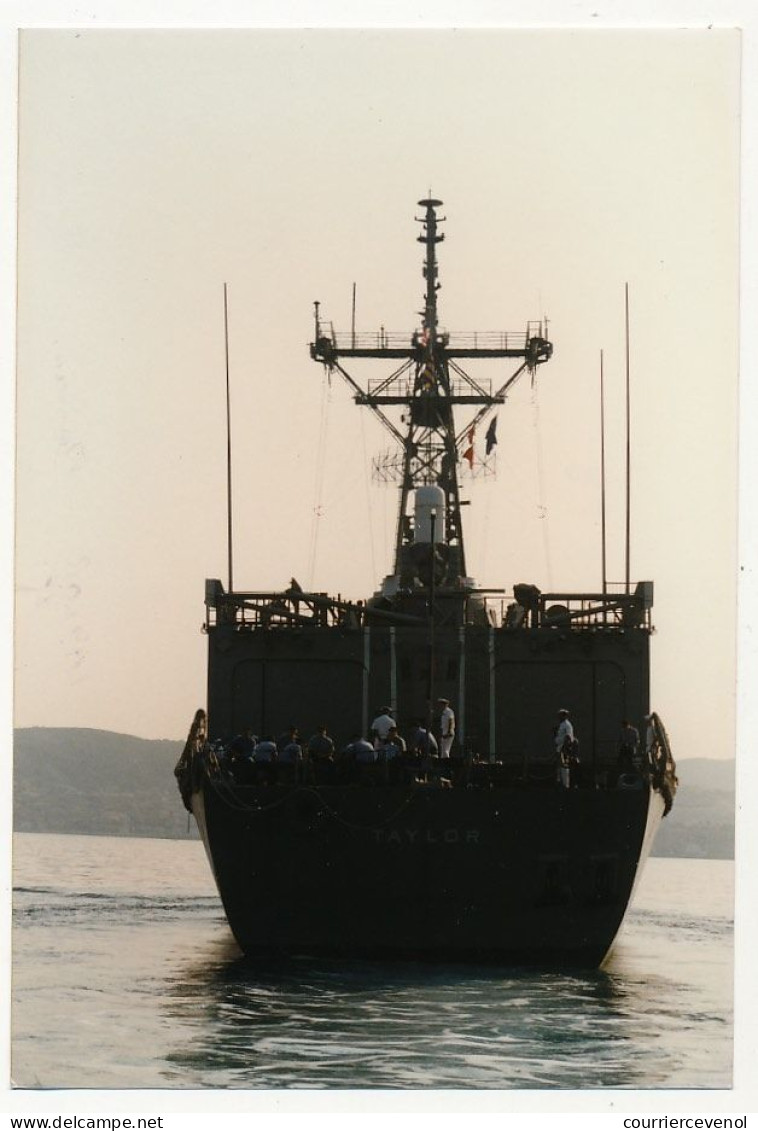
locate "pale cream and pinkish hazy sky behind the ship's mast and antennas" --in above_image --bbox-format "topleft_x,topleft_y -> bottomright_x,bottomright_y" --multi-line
16,29 -> 740,758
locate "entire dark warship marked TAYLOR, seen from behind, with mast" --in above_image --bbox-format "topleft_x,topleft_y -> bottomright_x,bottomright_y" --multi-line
175,197 -> 677,967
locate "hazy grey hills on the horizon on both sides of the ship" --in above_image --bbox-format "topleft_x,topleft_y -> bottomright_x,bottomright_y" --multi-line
14,727 -> 734,858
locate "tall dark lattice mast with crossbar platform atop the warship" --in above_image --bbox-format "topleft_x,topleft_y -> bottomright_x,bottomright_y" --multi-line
310,198 -> 552,586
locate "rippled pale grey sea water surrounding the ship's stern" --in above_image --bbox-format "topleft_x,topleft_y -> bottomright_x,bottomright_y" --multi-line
11,834 -> 733,1089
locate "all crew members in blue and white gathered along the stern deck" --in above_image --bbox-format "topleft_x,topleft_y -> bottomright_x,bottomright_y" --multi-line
207,699 -> 655,789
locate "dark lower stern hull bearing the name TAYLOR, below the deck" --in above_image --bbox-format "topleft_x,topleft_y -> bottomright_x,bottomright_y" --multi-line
192,780 -> 664,967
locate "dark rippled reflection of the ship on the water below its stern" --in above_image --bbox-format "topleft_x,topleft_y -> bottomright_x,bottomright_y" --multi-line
160,947 -> 678,1088
